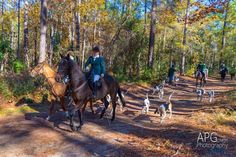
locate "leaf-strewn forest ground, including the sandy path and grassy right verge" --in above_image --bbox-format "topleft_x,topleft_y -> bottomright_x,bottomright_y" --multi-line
0,77 -> 236,157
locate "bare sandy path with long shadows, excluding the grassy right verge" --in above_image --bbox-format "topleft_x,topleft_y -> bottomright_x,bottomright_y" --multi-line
0,77 -> 236,157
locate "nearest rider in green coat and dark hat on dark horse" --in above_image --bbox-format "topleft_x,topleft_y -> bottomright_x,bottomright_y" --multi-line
85,46 -> 106,98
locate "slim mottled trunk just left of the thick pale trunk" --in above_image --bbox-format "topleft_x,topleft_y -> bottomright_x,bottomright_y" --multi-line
24,2 -> 29,67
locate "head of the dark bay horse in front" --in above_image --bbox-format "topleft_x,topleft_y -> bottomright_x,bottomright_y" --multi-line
56,54 -> 73,82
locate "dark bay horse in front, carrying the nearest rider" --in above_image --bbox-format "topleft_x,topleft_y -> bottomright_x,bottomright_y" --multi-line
57,54 -> 125,131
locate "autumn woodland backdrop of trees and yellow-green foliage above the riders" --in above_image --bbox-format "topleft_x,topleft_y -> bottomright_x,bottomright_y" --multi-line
0,0 -> 236,80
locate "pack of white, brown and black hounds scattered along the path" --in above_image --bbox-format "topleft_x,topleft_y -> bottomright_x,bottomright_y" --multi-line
106,77 -> 215,123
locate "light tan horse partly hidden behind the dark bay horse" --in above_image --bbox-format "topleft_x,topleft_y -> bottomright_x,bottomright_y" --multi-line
30,62 -> 94,120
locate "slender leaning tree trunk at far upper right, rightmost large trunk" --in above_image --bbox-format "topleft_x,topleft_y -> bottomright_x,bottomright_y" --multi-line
220,0 -> 230,64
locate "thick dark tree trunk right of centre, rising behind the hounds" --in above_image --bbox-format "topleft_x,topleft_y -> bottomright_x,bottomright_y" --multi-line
148,0 -> 157,69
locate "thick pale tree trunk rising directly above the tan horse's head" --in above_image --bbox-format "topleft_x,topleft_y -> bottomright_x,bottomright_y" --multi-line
39,0 -> 47,63
